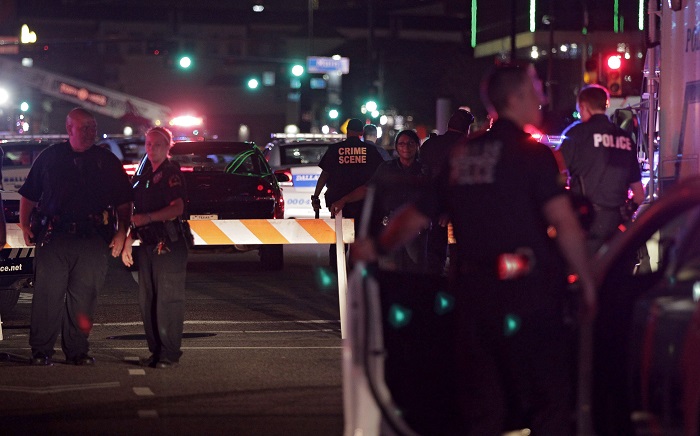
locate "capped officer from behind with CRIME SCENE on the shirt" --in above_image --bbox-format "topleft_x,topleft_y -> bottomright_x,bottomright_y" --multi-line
311,118 -> 384,266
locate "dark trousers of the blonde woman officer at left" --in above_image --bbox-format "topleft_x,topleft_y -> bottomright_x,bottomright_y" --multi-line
138,237 -> 187,362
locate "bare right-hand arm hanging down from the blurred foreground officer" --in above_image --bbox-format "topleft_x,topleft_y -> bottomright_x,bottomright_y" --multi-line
543,195 -> 597,317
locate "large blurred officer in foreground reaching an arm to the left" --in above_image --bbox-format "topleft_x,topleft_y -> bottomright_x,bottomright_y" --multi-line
352,66 -> 596,435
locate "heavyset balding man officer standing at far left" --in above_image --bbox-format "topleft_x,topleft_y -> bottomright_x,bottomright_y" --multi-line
19,108 -> 132,365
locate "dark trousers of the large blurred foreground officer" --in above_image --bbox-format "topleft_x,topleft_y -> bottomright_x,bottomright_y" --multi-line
455,274 -> 573,436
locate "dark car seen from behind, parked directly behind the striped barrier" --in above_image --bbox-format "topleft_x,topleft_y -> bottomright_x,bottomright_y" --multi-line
137,141 -> 288,270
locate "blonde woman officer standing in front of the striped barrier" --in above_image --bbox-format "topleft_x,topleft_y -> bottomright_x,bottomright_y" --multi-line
122,127 -> 190,368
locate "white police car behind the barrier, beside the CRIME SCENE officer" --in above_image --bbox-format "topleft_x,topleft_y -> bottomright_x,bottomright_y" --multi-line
264,133 -> 345,218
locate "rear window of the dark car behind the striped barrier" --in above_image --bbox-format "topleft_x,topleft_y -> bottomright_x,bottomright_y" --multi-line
171,149 -> 270,176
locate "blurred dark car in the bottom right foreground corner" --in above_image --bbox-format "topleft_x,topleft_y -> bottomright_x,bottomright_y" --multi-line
594,177 -> 700,435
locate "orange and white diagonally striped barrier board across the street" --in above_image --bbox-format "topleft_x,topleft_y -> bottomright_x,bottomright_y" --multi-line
4,218 -> 355,250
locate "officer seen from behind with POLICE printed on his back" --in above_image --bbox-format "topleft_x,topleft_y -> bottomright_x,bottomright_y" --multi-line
559,85 -> 644,254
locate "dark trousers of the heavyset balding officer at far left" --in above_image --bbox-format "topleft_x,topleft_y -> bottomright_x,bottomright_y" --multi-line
29,232 -> 109,360
